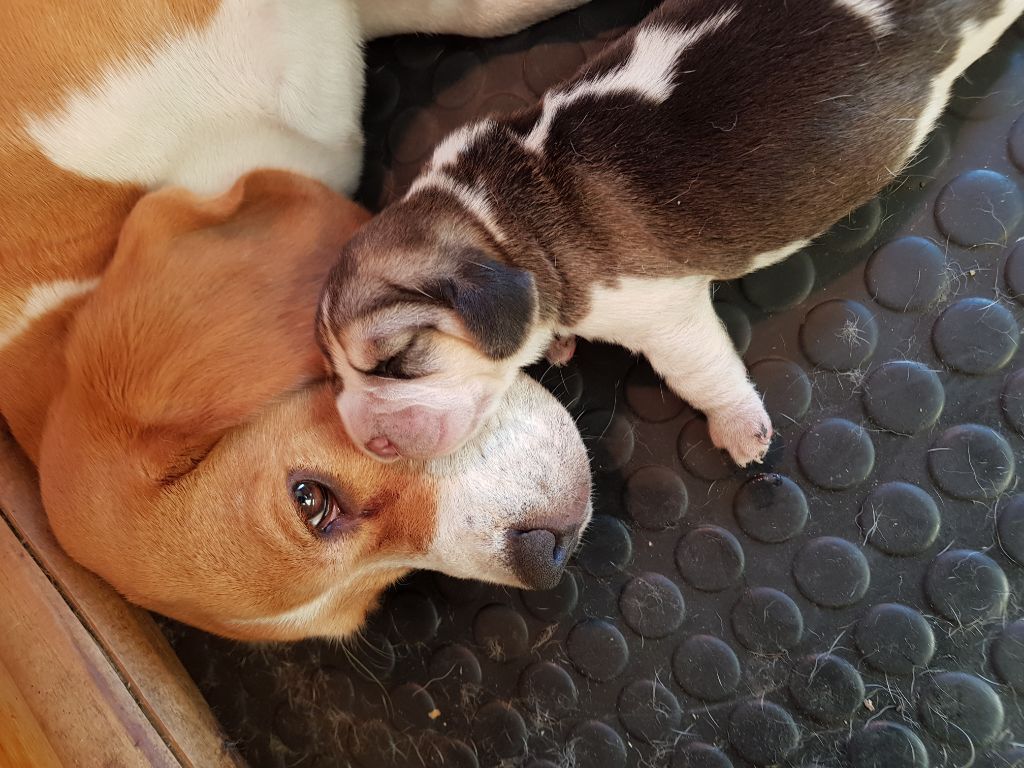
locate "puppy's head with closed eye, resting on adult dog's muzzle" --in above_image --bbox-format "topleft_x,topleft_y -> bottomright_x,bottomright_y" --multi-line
316,196 -> 548,461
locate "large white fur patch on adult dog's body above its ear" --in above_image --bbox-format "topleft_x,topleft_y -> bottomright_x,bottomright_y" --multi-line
26,0 -> 364,194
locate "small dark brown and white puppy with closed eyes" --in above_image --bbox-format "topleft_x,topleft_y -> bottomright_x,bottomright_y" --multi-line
317,0 -> 1024,465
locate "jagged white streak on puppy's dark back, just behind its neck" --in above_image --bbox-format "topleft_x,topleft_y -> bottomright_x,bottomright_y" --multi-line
523,7 -> 739,153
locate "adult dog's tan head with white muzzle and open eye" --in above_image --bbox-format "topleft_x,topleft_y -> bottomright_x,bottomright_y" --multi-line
39,172 -> 590,640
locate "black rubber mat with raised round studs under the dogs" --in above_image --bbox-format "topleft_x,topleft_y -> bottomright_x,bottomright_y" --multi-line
157,0 -> 1024,768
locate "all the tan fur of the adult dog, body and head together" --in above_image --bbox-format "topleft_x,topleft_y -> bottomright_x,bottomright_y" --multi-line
0,0 -> 403,639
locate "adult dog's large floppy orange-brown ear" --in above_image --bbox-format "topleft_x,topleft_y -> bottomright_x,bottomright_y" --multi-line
66,171 -> 368,479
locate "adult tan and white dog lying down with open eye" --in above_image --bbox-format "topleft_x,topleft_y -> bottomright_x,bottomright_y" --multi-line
0,0 -> 590,640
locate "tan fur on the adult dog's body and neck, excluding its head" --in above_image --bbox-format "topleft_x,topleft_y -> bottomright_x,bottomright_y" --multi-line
0,0 -> 217,450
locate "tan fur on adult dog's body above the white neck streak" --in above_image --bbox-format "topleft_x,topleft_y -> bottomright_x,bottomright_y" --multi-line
0,0 -> 218,252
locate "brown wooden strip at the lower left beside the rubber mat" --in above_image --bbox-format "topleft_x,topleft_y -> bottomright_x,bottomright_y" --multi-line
0,431 -> 242,768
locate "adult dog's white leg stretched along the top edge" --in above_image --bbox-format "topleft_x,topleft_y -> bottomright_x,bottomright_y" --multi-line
355,0 -> 590,39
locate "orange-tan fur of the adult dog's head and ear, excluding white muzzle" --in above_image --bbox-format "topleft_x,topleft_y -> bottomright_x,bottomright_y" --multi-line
39,172 -> 434,639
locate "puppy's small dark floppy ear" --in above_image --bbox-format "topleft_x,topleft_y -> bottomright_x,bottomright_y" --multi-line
439,251 -> 537,359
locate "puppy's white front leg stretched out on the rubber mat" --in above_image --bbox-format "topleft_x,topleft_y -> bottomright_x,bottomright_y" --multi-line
580,276 -> 772,467
